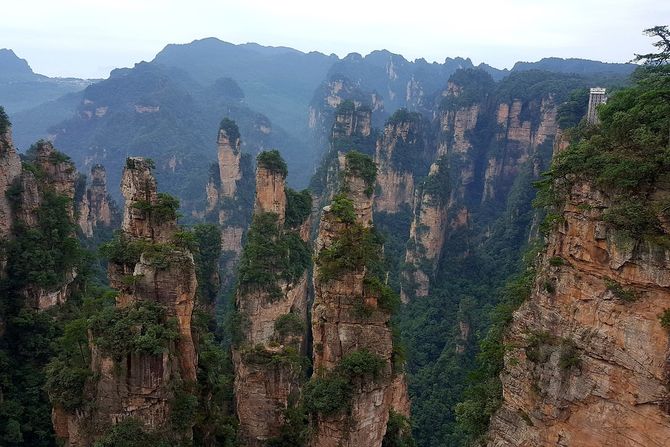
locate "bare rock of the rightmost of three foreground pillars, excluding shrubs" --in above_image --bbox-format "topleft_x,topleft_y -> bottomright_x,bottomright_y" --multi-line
310,154 -> 409,447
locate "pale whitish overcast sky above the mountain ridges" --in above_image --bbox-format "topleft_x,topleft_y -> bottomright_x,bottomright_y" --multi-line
0,0 -> 670,77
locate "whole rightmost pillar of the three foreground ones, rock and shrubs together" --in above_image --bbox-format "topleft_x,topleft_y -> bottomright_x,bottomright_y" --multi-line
310,152 -> 409,447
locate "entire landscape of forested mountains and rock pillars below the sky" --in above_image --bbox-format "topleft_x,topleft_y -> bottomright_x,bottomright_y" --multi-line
0,27 -> 670,447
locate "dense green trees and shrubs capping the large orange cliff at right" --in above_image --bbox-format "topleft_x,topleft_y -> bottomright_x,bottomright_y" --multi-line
537,65 -> 670,239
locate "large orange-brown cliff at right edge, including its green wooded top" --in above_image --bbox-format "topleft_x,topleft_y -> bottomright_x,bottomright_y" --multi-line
487,65 -> 670,446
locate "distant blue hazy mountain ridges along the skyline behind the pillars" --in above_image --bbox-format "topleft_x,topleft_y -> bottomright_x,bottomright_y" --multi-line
0,38 -> 635,201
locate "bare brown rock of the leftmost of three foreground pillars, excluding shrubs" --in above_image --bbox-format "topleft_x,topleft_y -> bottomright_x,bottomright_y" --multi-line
54,158 -> 197,446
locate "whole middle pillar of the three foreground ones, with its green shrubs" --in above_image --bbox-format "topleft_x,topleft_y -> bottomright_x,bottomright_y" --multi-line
233,151 -> 309,447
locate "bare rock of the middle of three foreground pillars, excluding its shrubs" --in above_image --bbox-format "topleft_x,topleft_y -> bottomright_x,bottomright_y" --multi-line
233,156 -> 308,447
